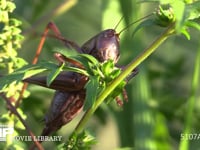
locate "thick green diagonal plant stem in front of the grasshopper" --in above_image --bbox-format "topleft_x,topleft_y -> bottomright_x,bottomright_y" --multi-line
74,24 -> 174,133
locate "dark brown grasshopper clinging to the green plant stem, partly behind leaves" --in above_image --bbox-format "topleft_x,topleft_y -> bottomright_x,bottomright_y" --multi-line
24,17 -> 141,139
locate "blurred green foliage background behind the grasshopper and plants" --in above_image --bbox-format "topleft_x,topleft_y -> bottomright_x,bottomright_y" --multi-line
0,0 -> 200,150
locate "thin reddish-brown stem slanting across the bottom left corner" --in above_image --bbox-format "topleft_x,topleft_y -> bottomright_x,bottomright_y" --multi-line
0,93 -> 43,150
